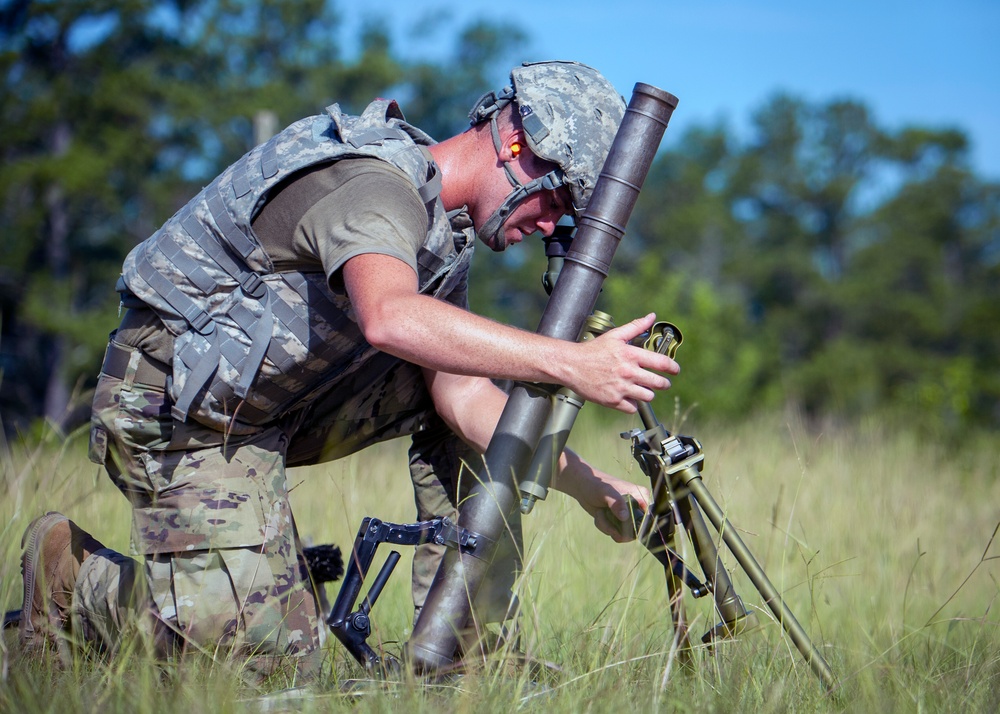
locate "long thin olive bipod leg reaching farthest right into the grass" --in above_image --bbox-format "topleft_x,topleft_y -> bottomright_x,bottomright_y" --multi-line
678,468 -> 837,691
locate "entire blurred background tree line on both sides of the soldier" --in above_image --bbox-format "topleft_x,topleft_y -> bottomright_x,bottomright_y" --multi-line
0,0 -> 1000,434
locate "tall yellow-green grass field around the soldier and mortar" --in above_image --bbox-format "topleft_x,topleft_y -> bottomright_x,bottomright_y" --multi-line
0,412 -> 1000,714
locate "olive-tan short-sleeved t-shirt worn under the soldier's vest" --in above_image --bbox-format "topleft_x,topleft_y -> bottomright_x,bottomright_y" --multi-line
116,158 -> 430,356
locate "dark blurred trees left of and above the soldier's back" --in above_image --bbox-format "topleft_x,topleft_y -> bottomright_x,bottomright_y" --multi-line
0,0 -> 540,428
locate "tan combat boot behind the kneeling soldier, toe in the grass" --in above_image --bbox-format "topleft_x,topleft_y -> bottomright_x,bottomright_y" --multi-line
18,511 -> 104,661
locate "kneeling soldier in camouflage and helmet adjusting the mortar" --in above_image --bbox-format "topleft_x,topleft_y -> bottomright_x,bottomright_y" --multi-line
20,62 -> 678,678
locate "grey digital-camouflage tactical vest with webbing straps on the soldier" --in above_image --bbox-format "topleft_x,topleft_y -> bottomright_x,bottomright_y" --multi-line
119,100 -> 474,434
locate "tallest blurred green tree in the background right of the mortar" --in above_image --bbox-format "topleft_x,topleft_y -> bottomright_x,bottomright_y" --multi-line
728,96 -> 881,398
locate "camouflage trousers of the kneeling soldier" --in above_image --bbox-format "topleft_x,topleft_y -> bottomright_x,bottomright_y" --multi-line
73,336 -> 479,679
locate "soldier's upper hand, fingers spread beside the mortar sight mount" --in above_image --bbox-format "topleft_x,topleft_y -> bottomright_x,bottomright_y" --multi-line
567,313 -> 680,414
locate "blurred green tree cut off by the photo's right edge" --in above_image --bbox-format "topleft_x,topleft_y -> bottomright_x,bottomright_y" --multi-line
842,130 -> 1000,427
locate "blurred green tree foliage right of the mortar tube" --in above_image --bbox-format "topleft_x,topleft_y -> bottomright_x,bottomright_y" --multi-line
592,96 -> 1000,429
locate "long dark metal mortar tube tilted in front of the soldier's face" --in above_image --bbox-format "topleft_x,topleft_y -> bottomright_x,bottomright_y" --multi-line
407,83 -> 677,673
